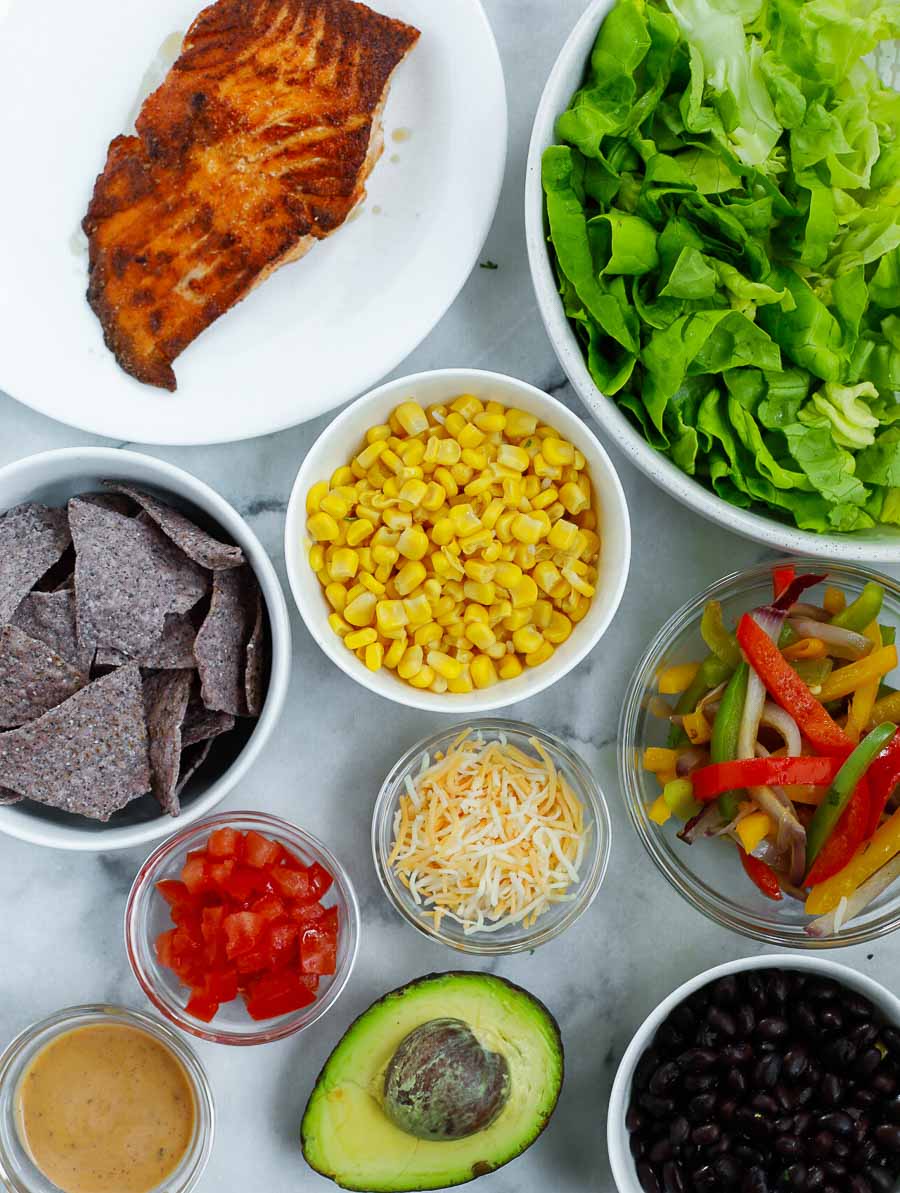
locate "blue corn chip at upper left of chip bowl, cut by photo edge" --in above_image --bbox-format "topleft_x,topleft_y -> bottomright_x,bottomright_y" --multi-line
0,502 -> 72,625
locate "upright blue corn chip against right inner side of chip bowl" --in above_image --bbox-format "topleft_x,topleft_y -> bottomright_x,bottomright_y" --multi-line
193,563 -> 259,717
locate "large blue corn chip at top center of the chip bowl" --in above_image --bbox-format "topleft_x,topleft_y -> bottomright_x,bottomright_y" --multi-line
68,497 -> 209,659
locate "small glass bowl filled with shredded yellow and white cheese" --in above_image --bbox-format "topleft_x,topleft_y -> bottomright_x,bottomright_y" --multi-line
372,717 -> 610,956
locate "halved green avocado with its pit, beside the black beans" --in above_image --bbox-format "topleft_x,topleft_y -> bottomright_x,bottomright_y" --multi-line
301,972 -> 563,1193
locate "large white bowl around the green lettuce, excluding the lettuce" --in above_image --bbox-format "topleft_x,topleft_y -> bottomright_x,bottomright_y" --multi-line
525,0 -> 900,563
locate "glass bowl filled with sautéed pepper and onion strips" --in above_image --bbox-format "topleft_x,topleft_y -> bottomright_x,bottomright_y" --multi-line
618,558 -> 900,948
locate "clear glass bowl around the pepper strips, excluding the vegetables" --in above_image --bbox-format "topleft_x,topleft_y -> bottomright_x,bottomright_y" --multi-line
618,558 -> 900,948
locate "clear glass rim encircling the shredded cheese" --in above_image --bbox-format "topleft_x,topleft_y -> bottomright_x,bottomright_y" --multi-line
371,716 -> 612,957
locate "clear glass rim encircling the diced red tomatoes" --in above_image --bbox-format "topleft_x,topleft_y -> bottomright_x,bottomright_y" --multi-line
123,808 -> 360,1047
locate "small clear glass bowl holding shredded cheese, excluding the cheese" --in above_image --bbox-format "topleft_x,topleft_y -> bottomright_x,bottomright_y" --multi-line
372,717 -> 611,957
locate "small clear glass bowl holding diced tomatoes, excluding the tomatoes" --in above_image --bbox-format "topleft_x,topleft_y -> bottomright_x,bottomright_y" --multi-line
125,811 -> 359,1044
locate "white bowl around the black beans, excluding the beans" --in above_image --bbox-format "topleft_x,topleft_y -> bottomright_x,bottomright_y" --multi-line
606,953 -> 900,1193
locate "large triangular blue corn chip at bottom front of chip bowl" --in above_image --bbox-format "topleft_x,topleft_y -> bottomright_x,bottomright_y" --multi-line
0,666 -> 150,821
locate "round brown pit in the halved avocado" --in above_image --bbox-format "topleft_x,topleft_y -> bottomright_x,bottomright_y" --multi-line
384,1019 -> 510,1142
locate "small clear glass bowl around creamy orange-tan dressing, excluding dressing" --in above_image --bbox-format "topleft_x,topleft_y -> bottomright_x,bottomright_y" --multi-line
0,1003 -> 216,1193
